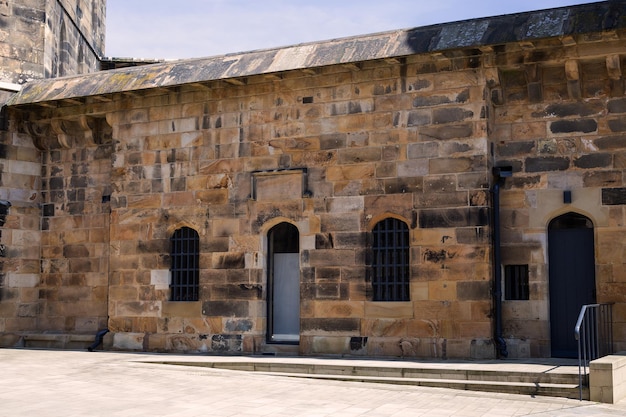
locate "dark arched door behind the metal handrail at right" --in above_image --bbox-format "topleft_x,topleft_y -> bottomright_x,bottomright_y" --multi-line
548,213 -> 596,358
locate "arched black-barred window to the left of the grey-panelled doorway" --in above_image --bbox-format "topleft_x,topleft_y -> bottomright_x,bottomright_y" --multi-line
170,227 -> 200,301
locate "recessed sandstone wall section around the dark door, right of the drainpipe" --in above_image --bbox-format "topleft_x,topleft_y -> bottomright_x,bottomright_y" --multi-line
491,48 -> 626,357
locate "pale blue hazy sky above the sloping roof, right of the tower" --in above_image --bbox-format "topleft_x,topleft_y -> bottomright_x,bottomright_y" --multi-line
105,0 -> 594,59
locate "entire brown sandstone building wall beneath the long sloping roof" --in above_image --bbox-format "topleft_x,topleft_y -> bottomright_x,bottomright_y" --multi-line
0,6 -> 626,358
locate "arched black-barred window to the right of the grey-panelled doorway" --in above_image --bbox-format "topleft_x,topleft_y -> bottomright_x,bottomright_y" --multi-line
372,218 -> 410,301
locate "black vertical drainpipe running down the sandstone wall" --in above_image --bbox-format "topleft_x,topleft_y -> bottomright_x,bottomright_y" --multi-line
491,166 -> 513,358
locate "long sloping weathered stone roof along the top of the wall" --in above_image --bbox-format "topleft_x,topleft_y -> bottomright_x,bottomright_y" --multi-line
8,0 -> 626,106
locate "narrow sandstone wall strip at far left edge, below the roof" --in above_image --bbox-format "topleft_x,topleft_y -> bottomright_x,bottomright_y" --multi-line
0,104 -> 41,345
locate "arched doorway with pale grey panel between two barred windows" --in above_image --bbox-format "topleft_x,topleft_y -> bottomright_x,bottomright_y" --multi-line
267,223 -> 300,343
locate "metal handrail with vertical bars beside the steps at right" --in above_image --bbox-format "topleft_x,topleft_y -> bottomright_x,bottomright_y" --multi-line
574,303 -> 613,401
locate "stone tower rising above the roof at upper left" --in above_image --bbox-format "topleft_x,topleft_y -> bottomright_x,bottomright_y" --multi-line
0,0 -> 106,84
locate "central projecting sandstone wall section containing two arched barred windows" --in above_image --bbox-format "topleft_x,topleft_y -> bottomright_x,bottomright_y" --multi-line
88,51 -> 493,357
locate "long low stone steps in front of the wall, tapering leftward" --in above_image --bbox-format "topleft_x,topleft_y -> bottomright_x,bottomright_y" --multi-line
161,359 -> 589,399
